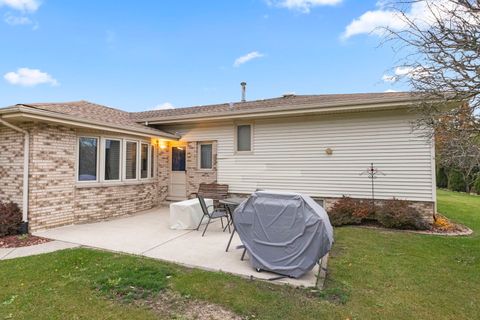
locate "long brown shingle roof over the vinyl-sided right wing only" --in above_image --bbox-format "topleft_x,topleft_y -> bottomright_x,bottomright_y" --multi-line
131,92 -> 418,121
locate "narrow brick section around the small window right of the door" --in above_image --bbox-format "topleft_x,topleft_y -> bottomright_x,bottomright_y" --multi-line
186,141 -> 217,198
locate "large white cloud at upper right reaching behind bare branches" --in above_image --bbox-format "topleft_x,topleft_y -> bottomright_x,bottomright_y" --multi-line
341,0 -> 464,39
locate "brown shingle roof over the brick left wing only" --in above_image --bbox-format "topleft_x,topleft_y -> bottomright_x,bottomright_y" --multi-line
18,100 -> 178,136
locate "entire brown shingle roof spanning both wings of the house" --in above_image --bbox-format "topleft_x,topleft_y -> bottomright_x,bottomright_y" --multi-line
5,92 -> 428,132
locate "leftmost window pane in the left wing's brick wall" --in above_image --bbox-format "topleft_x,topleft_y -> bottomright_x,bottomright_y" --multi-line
78,137 -> 98,181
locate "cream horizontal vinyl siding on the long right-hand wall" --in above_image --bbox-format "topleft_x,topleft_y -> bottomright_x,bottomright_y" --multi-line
164,111 -> 435,201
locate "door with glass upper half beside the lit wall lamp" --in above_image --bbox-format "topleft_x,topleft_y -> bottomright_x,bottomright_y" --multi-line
168,147 -> 187,200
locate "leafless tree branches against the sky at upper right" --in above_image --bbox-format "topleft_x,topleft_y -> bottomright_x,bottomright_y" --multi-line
384,0 -> 480,131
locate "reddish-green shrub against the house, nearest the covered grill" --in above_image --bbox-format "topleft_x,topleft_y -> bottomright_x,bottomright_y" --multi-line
328,196 -> 373,226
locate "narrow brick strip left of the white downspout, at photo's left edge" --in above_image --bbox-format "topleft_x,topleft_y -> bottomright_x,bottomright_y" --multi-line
0,124 -> 24,208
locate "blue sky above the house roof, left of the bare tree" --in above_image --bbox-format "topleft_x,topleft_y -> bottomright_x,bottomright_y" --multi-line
0,0 -> 412,111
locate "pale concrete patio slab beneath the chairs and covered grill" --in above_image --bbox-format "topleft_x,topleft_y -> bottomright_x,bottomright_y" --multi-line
35,207 -> 326,287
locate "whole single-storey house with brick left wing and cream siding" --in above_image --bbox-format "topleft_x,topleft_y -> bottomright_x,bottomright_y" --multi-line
0,93 -> 442,231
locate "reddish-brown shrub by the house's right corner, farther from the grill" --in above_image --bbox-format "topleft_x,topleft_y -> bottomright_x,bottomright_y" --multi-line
376,198 -> 430,230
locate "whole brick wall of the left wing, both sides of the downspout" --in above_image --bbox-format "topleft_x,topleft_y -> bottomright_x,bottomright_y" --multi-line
0,124 -> 169,231
